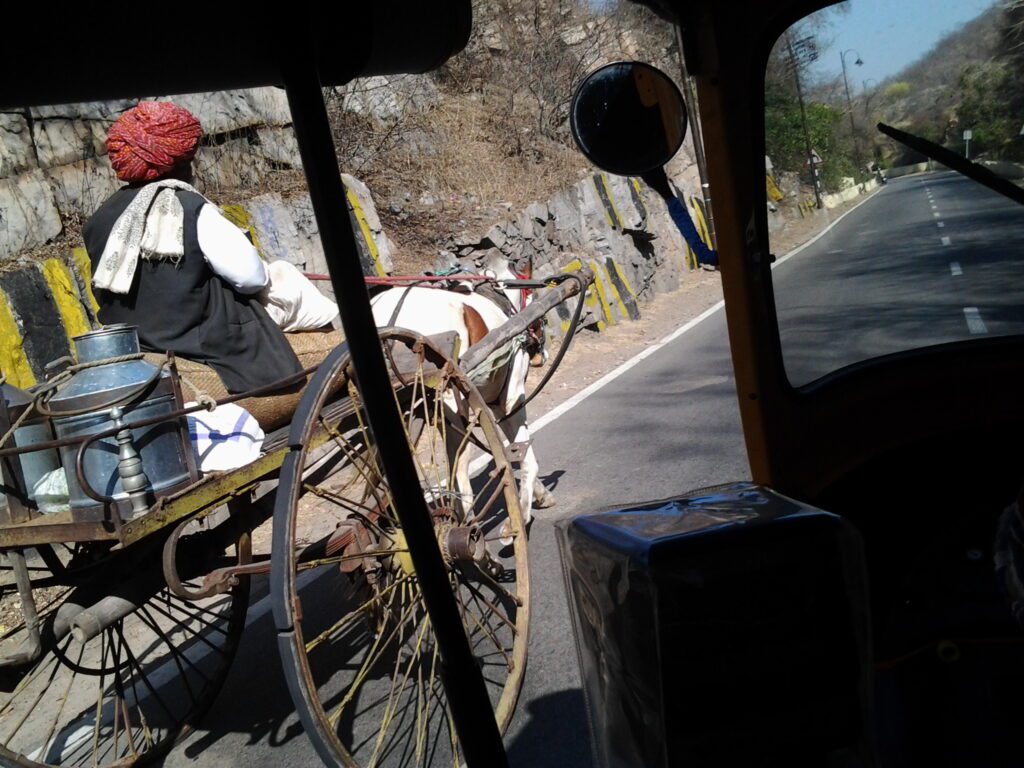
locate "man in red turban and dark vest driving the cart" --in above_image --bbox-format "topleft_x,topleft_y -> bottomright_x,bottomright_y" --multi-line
82,101 -> 302,399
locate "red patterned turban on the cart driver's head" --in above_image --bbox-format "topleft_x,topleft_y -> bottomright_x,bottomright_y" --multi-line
106,101 -> 203,183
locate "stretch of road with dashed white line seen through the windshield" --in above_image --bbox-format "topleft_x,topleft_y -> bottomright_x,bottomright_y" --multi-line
775,172 -> 1024,384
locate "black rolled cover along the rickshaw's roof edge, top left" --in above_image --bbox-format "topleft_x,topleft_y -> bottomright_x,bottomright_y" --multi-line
0,0 -> 472,109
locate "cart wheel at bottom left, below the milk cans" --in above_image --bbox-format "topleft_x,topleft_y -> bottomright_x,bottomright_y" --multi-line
0,540 -> 249,768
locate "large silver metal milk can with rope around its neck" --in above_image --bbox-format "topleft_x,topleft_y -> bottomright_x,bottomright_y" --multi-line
48,325 -> 191,520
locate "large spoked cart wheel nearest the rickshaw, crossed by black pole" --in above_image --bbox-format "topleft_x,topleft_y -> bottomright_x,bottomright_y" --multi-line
271,330 -> 529,766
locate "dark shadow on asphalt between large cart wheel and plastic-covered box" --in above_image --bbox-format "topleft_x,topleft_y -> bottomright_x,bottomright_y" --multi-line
506,688 -> 594,768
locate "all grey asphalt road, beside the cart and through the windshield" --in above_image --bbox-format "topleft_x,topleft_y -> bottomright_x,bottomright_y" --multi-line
167,173 -> 1024,768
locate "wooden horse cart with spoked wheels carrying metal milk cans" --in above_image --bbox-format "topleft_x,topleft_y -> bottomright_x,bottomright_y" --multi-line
0,275 -> 586,765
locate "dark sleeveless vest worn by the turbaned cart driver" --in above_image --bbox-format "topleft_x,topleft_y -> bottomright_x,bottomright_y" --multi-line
82,186 -> 302,393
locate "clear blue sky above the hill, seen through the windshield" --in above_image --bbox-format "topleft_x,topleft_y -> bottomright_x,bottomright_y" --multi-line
802,0 -> 997,92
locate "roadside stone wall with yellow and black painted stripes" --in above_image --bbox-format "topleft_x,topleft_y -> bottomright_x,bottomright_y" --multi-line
0,88 -> 699,387
